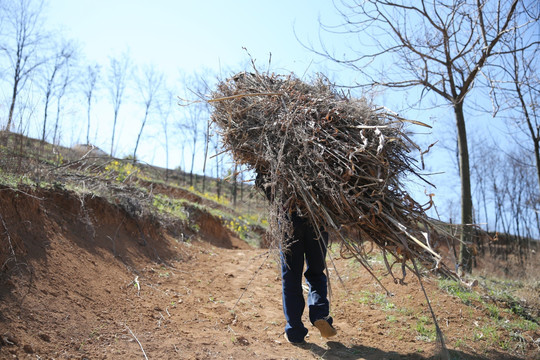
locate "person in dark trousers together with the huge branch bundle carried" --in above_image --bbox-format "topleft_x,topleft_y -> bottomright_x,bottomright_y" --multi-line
209,69 -> 459,352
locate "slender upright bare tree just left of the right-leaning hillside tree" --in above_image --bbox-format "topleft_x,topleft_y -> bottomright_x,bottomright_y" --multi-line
108,52 -> 131,156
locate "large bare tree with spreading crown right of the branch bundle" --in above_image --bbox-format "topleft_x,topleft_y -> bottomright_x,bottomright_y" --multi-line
318,0 -> 532,272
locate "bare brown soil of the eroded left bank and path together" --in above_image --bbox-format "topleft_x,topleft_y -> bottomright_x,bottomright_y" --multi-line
0,184 -> 540,359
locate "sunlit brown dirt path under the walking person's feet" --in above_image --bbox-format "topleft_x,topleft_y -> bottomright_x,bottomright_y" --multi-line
0,236 -> 528,359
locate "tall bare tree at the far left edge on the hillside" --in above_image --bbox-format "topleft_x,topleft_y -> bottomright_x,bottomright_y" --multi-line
0,0 -> 46,131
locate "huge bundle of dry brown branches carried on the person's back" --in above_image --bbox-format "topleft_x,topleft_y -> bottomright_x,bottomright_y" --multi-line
210,73 -> 454,282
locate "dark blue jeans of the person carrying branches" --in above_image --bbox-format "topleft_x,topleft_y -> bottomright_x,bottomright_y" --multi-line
281,213 -> 332,342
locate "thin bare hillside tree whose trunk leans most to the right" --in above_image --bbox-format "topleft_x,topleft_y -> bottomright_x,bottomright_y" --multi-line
133,65 -> 163,161
